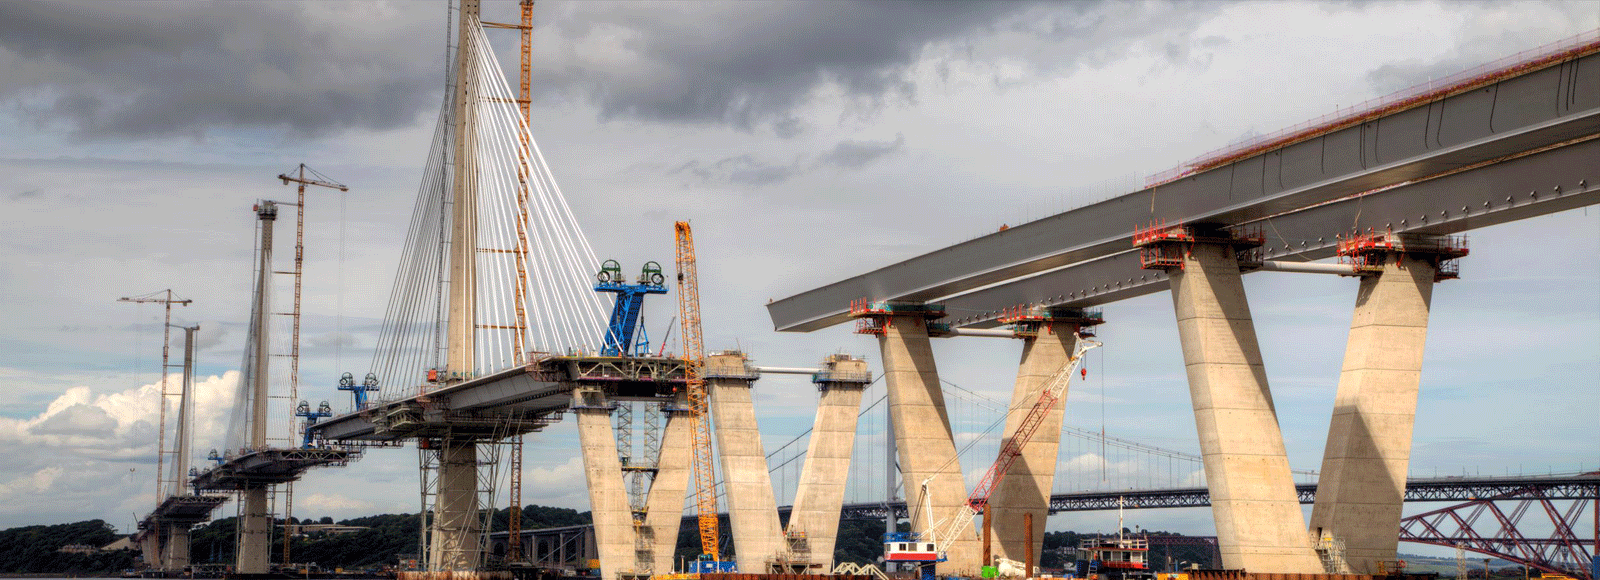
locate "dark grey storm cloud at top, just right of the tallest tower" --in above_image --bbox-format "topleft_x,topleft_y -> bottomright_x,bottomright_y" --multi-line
547,2 -> 1030,130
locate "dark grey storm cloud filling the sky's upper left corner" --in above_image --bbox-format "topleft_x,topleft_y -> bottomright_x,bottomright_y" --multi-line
0,2 -> 443,139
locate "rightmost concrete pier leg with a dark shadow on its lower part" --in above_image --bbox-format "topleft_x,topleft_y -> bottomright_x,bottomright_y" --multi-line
1310,253 -> 1435,574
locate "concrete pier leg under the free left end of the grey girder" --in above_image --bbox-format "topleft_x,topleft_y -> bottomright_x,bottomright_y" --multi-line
878,314 -> 979,575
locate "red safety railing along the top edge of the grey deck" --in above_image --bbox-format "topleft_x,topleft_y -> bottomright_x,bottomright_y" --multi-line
1144,29 -> 1600,187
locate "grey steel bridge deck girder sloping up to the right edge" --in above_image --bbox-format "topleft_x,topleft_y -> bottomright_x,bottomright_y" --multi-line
768,40 -> 1600,332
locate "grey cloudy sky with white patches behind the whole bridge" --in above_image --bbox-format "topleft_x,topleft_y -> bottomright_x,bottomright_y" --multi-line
0,0 -> 1600,544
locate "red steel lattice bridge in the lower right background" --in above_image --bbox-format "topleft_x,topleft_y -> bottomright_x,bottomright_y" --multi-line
1400,471 -> 1600,580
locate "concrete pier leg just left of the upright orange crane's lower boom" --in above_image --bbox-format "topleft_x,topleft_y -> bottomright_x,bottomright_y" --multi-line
645,394 -> 694,575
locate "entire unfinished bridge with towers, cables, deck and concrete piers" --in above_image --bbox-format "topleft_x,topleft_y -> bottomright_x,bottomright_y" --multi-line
116,6 -> 1600,580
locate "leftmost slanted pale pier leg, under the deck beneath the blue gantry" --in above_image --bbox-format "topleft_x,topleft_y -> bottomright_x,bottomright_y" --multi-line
573,389 -> 636,580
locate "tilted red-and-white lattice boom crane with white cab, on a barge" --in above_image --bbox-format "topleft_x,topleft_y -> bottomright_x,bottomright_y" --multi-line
883,335 -> 1101,580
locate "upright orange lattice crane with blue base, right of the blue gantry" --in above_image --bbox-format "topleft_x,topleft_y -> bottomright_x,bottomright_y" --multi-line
672,221 -> 734,574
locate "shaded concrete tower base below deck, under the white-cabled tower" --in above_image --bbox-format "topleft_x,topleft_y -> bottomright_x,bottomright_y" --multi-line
427,439 -> 483,572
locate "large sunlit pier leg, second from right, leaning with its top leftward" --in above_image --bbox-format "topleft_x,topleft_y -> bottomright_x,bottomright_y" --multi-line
1170,244 -> 1318,574
